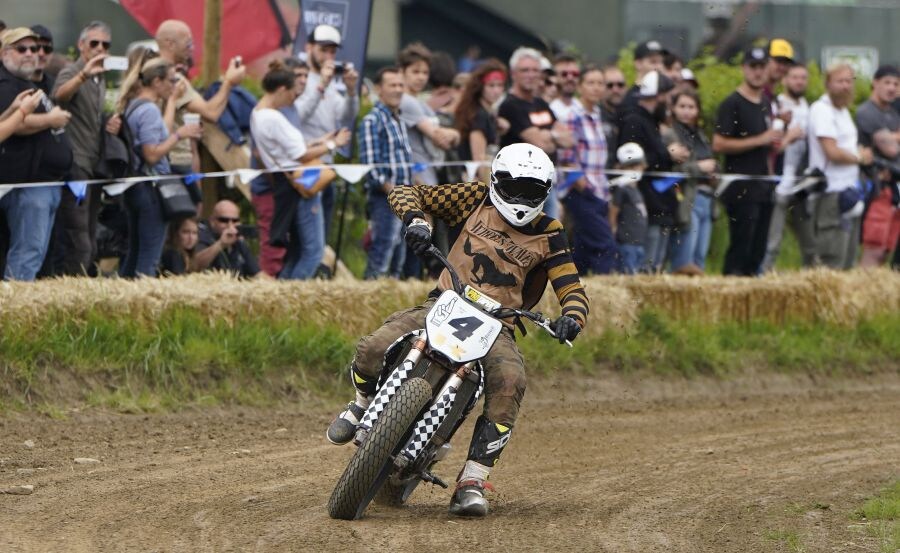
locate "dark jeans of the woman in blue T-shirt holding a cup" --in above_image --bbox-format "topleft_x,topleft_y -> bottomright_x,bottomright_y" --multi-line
119,182 -> 166,278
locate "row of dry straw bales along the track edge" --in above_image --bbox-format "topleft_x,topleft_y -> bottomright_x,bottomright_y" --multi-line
0,269 -> 900,335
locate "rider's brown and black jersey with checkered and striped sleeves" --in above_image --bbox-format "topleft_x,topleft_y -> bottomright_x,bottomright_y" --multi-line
388,182 -> 589,328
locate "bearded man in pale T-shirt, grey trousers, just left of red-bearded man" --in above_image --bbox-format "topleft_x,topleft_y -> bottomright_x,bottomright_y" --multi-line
762,64 -> 815,272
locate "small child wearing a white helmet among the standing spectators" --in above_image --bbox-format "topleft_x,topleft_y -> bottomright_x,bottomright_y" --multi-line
609,142 -> 647,275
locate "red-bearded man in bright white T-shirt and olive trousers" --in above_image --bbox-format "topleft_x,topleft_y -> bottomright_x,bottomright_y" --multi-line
809,64 -> 872,269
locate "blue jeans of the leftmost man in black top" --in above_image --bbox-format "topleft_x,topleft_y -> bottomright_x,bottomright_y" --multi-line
0,186 -> 60,281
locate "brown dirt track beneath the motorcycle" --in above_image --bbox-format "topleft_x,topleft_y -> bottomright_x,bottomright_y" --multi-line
0,375 -> 900,552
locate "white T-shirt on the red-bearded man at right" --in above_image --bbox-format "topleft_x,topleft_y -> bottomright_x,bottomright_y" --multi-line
808,94 -> 859,192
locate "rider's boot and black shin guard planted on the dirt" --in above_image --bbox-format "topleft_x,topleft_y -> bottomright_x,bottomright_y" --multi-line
450,415 -> 512,517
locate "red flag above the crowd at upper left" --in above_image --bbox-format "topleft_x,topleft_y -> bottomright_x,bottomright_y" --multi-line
119,0 -> 291,73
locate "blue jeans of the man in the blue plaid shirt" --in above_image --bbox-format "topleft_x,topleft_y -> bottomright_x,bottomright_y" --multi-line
364,192 -> 406,279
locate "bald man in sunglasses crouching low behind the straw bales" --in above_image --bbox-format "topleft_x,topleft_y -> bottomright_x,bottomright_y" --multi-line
192,200 -> 260,278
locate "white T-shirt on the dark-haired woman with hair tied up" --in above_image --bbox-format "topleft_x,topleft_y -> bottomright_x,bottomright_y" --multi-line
250,108 -> 306,169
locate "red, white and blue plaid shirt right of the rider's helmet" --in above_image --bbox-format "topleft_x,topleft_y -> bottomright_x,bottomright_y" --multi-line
559,101 -> 609,201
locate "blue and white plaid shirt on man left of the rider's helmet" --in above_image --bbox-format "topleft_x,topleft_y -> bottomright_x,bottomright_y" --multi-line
357,102 -> 412,190
